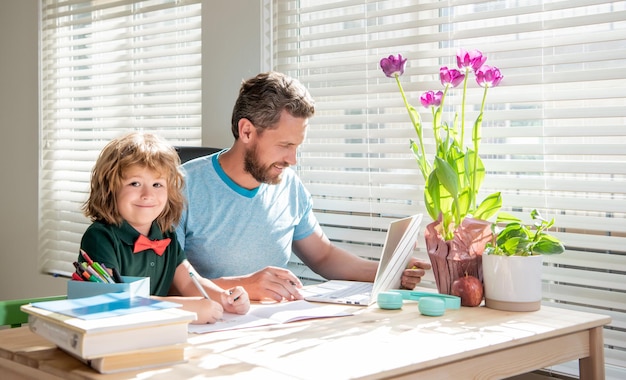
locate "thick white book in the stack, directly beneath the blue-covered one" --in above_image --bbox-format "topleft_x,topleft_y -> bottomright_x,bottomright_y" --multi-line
21,301 -> 196,359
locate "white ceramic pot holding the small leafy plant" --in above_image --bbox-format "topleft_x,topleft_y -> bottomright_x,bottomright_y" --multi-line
482,255 -> 543,311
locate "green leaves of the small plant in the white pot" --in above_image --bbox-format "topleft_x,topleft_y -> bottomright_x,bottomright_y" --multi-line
484,210 -> 565,256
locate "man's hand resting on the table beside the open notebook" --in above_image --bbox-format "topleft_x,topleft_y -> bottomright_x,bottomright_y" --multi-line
240,266 -> 304,302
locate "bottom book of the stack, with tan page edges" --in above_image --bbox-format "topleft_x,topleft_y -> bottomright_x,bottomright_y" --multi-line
78,344 -> 187,373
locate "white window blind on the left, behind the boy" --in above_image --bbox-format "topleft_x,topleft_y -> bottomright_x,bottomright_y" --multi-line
39,0 -> 201,276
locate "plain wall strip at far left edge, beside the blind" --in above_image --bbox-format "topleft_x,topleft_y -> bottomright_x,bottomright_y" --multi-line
0,0 -> 65,299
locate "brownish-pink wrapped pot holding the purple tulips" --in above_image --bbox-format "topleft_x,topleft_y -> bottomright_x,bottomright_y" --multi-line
424,217 -> 492,294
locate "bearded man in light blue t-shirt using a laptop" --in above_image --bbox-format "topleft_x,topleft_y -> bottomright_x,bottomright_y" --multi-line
176,72 -> 430,301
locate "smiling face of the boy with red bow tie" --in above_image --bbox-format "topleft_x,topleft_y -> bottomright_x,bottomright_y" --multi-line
116,165 -> 167,235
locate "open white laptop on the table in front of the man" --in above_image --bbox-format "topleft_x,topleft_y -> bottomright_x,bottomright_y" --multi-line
301,214 -> 422,306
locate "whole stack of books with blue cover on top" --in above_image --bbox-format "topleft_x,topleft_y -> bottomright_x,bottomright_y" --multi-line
21,293 -> 196,373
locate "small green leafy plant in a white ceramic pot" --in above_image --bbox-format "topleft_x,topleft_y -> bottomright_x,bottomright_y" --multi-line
482,210 -> 565,311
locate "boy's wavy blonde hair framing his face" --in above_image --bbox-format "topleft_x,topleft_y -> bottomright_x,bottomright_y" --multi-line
82,132 -> 185,232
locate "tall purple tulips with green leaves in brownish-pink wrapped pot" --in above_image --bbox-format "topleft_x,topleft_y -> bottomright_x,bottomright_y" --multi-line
380,49 -> 503,294
